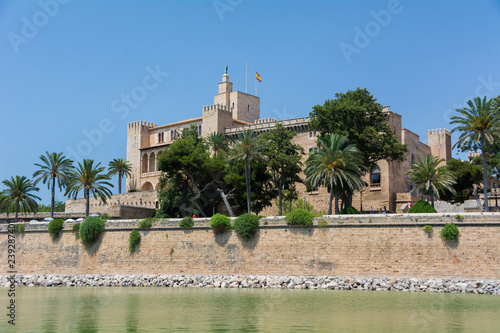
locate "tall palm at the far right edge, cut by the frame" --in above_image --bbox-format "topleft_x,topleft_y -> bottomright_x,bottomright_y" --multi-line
450,96 -> 500,212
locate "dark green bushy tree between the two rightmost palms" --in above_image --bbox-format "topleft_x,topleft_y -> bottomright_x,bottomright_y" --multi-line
440,158 -> 483,203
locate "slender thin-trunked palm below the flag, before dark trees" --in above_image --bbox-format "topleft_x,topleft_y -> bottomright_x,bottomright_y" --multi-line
230,129 -> 265,214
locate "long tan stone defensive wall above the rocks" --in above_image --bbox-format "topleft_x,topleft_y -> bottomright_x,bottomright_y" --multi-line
0,213 -> 500,280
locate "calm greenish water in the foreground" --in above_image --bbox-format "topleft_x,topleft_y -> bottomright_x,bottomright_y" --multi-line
0,288 -> 500,332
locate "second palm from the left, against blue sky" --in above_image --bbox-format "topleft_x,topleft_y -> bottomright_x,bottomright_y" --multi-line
33,151 -> 73,218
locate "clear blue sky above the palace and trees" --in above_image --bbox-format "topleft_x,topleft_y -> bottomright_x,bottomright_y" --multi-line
0,0 -> 500,204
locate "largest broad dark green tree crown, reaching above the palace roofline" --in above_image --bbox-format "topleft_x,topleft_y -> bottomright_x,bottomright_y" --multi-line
309,88 -> 406,170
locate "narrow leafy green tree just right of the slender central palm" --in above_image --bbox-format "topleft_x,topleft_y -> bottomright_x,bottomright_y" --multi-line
262,123 -> 304,216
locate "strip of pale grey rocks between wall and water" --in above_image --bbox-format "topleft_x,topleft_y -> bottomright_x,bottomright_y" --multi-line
0,274 -> 500,295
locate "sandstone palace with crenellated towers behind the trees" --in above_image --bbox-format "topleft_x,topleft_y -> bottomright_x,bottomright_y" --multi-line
126,74 -> 451,215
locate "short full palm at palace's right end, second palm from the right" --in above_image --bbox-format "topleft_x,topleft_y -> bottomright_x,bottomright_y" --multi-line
406,154 -> 456,207
